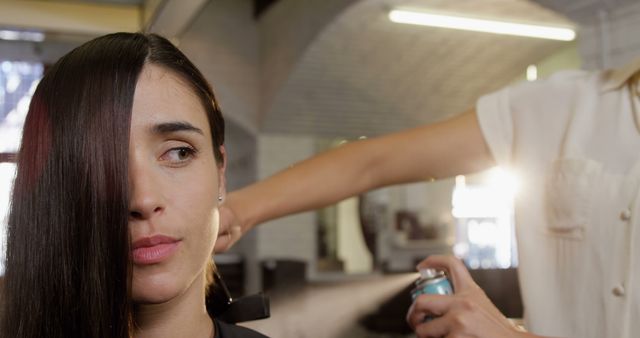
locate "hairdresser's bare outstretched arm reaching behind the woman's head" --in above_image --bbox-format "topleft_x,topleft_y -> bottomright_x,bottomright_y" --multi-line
216,110 -> 494,251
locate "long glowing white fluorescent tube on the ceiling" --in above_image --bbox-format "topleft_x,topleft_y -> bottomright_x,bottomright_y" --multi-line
389,9 -> 576,41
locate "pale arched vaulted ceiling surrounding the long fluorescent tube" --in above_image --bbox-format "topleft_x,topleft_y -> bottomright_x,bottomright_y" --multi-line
262,0 -> 572,137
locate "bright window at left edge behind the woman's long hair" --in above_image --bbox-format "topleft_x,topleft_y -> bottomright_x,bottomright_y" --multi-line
0,60 -> 43,275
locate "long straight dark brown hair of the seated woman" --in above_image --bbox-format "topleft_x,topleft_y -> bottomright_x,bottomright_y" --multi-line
0,33 -> 224,338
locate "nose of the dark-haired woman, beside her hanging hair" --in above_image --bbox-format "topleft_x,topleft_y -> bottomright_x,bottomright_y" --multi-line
129,161 -> 164,220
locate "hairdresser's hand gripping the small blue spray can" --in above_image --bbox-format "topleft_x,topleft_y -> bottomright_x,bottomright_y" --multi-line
407,256 -> 526,338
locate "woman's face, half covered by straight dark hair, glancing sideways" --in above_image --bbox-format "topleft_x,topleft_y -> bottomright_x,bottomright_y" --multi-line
129,64 -> 224,304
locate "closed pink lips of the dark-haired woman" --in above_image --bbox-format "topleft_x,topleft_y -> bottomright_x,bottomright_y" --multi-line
131,235 -> 180,265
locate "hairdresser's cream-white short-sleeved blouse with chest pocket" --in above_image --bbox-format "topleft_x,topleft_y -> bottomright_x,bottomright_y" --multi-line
476,56 -> 640,338
